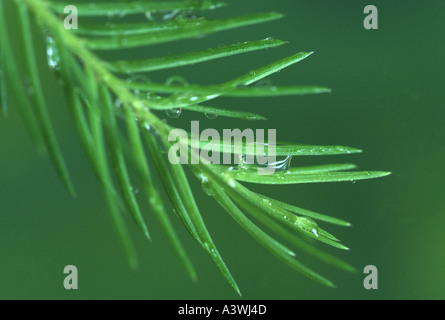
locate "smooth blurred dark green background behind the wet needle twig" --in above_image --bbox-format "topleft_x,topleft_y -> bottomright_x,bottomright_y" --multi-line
0,0 -> 445,299
